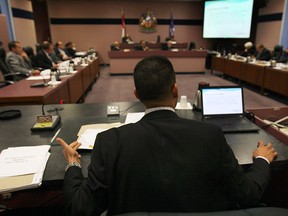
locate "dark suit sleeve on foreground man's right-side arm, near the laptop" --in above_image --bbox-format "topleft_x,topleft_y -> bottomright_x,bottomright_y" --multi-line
222,131 -> 270,208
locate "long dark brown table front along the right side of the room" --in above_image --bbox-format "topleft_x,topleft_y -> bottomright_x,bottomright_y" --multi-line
211,56 -> 288,97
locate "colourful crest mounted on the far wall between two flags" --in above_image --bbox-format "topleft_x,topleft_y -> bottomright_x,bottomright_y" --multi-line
139,10 -> 157,33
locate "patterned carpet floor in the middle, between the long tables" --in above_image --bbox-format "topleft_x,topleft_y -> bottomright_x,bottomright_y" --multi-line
84,67 -> 287,109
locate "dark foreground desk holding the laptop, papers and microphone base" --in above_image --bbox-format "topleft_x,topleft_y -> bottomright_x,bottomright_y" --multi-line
0,102 -> 288,208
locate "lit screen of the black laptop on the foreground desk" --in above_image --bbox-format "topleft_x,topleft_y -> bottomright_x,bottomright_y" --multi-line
201,86 -> 244,116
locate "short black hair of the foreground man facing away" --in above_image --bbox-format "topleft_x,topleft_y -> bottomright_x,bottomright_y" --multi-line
133,56 -> 176,102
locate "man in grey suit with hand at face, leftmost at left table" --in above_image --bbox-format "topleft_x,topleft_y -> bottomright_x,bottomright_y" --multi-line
5,41 -> 40,75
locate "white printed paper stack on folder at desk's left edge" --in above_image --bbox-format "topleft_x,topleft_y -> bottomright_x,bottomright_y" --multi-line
0,145 -> 50,193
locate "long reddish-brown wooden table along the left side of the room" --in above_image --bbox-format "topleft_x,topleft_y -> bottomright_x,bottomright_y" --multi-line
0,58 -> 100,106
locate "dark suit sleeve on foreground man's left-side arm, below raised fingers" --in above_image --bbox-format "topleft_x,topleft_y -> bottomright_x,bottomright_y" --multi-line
64,136 -> 108,216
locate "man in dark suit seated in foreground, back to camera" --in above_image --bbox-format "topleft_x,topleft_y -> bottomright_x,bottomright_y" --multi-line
57,56 -> 277,215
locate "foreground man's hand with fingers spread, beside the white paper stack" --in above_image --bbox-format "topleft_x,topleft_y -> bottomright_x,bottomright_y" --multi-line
56,138 -> 81,163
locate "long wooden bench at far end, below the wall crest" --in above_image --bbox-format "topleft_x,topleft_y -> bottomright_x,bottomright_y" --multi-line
108,49 -> 207,74
